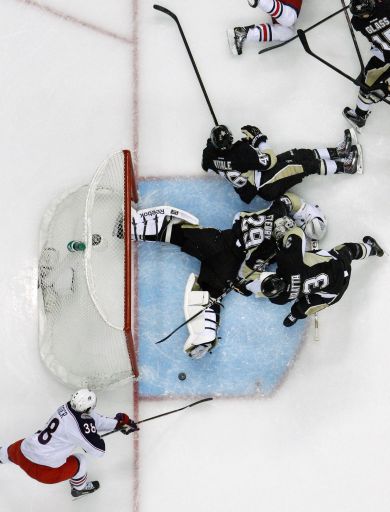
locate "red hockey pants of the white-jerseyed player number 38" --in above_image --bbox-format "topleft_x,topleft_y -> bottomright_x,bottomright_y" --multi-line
8,439 -> 79,484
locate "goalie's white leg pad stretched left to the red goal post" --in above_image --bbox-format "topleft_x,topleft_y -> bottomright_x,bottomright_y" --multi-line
131,206 -> 199,242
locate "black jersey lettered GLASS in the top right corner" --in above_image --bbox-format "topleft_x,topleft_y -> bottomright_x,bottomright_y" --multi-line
351,0 -> 390,62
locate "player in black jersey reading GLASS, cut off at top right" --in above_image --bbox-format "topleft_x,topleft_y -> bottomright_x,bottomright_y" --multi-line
343,0 -> 390,129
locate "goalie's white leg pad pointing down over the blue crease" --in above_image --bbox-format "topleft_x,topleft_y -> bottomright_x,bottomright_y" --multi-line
183,274 -> 218,359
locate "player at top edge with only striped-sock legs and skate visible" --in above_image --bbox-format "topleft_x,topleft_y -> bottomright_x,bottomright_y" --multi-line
227,0 -> 302,55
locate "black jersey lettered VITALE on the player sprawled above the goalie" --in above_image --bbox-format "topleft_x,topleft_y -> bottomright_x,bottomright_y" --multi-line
202,139 -> 276,203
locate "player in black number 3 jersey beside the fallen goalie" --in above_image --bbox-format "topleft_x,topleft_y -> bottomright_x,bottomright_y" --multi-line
235,223 -> 383,327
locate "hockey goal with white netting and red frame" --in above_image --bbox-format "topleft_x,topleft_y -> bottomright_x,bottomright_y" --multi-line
38,150 -> 138,389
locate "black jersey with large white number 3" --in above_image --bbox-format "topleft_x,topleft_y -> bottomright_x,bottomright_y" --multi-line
270,227 -> 351,318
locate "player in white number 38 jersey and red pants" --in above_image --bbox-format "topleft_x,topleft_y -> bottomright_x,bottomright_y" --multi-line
0,389 -> 138,497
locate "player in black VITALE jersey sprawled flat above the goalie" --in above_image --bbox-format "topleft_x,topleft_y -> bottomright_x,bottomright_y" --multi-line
202,125 -> 363,203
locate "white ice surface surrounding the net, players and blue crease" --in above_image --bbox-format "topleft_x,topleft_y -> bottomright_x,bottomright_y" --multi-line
0,0 -> 390,512
